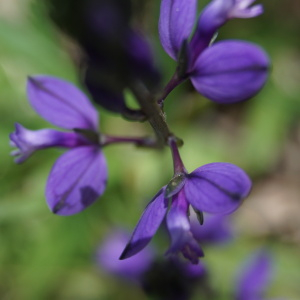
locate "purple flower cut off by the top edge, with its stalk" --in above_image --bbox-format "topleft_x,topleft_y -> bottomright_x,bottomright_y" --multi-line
159,0 -> 269,103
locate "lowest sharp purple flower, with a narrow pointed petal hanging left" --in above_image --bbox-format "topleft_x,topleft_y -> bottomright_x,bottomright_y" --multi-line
121,163 -> 251,264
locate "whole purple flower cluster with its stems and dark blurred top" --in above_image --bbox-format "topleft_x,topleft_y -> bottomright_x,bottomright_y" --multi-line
10,0 -> 269,270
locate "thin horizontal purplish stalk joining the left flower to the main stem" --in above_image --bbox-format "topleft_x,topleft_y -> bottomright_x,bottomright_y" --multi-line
100,134 -> 157,148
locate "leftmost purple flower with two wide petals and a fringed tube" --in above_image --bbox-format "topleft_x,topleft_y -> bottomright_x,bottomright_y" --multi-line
10,75 -> 107,215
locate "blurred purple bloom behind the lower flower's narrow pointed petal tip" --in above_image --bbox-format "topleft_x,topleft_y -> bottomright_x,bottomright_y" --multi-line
96,230 -> 154,280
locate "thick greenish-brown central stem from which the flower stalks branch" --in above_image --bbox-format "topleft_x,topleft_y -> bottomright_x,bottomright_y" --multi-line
131,81 -> 174,148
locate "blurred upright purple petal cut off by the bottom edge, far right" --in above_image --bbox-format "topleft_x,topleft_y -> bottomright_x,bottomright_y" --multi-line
235,250 -> 273,300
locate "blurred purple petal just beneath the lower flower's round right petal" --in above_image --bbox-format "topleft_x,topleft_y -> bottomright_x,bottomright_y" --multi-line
190,214 -> 233,244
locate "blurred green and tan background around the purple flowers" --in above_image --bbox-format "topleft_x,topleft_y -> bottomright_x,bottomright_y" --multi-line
0,0 -> 300,300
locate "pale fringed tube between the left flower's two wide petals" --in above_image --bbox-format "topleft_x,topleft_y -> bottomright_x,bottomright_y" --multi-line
9,123 -> 87,163
